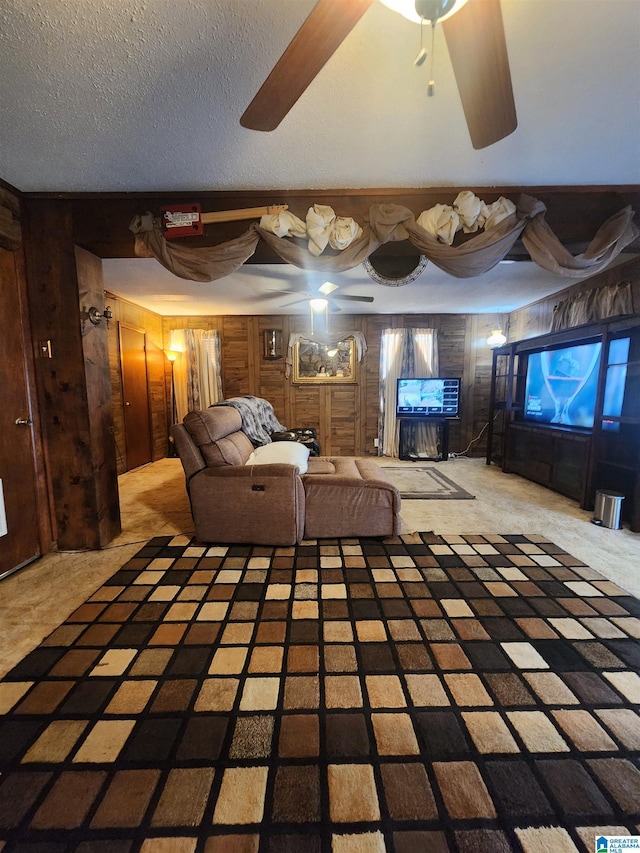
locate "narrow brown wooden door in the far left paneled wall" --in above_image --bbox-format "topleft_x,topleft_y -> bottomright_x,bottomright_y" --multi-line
120,323 -> 152,471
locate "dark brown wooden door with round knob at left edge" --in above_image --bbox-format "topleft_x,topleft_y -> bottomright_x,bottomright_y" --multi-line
0,249 -> 40,577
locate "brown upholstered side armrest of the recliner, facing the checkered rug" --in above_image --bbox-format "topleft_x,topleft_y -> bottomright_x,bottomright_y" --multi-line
188,464 -> 305,545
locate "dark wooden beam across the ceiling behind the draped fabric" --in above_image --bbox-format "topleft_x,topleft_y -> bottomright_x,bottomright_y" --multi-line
16,184 -> 640,263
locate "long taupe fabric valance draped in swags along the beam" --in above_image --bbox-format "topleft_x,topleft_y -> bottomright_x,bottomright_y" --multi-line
129,195 -> 640,282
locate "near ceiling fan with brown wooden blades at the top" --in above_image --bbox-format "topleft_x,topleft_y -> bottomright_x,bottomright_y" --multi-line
240,0 -> 517,149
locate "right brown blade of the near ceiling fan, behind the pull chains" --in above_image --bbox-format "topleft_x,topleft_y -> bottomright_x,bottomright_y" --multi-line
442,0 -> 518,149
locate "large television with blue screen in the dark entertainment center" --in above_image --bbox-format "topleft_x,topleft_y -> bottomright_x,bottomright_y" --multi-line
523,341 -> 602,429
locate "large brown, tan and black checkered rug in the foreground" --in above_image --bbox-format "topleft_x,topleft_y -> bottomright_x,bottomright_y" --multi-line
0,533 -> 640,853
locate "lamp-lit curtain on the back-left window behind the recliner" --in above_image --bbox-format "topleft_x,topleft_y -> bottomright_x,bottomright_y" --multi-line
170,329 -> 223,423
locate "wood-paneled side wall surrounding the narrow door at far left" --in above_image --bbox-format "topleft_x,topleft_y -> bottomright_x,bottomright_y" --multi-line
105,293 -> 171,474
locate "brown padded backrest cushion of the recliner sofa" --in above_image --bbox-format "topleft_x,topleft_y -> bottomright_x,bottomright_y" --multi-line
183,406 -> 253,468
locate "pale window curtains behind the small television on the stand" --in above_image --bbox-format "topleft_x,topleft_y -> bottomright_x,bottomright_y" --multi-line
378,329 -> 438,456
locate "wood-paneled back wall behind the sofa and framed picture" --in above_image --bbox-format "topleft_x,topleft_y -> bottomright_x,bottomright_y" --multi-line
162,314 -> 498,456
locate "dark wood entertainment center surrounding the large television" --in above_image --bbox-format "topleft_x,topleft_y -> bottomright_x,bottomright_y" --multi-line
487,315 -> 640,532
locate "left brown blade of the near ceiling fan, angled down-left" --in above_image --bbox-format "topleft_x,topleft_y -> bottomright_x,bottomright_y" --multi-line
240,0 -> 373,130
